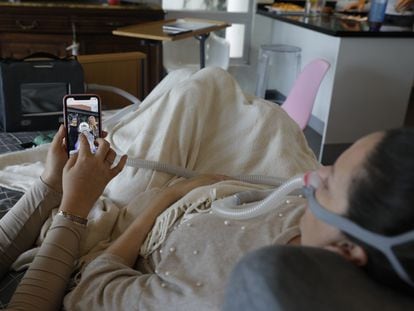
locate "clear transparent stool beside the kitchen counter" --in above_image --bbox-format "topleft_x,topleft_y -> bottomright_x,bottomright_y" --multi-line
255,44 -> 302,104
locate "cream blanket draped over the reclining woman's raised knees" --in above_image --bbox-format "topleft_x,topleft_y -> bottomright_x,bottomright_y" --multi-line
0,68 -> 317,270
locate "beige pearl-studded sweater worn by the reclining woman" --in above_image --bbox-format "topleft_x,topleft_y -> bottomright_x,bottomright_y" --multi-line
66,186 -> 305,311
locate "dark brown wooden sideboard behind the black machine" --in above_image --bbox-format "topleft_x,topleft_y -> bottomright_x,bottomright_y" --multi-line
0,0 -> 164,94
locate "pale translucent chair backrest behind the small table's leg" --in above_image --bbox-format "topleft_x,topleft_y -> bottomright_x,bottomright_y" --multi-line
163,33 -> 230,72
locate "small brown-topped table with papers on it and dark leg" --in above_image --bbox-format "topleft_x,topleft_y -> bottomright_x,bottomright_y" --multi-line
112,18 -> 230,68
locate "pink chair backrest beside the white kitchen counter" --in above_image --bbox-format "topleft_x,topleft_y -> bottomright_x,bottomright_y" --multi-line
282,59 -> 330,129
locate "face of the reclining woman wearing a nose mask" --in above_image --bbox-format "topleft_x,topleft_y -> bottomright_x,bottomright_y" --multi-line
300,132 -> 383,247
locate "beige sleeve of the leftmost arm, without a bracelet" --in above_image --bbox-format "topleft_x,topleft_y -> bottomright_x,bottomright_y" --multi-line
0,179 -> 62,278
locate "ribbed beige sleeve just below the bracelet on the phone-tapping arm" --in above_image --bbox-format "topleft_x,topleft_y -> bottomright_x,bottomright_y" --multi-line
8,215 -> 86,310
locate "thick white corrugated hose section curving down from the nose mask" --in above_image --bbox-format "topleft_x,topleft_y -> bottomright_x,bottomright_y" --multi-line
211,175 -> 304,220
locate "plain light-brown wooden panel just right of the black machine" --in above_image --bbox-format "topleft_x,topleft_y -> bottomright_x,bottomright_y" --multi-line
78,52 -> 146,109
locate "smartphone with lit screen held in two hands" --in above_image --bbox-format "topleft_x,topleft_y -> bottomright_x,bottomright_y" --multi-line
63,94 -> 102,155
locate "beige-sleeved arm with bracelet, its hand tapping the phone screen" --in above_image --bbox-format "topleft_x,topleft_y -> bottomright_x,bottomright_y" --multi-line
8,135 -> 126,310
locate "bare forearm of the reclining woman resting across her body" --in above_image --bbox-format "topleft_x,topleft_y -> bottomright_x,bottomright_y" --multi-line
105,175 -> 227,267
